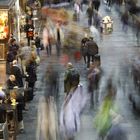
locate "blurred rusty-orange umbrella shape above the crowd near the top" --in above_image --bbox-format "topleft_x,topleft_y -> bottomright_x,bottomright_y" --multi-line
42,7 -> 69,25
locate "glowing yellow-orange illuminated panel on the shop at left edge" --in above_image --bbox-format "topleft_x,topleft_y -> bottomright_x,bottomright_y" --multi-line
0,10 -> 8,40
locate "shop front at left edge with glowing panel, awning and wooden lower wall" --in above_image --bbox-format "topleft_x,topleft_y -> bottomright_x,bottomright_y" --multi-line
0,0 -> 16,86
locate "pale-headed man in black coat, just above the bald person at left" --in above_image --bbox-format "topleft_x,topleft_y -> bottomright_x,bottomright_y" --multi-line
11,60 -> 23,87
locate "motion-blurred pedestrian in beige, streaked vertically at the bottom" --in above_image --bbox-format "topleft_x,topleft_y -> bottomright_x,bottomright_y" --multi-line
36,94 -> 58,140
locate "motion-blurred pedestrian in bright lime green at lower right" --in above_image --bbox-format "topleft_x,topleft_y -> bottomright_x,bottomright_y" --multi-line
94,79 -> 116,140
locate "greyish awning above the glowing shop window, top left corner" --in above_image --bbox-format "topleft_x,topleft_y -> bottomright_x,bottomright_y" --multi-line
0,0 -> 16,9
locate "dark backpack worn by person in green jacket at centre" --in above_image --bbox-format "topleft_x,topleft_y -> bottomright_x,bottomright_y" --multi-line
68,69 -> 80,86
